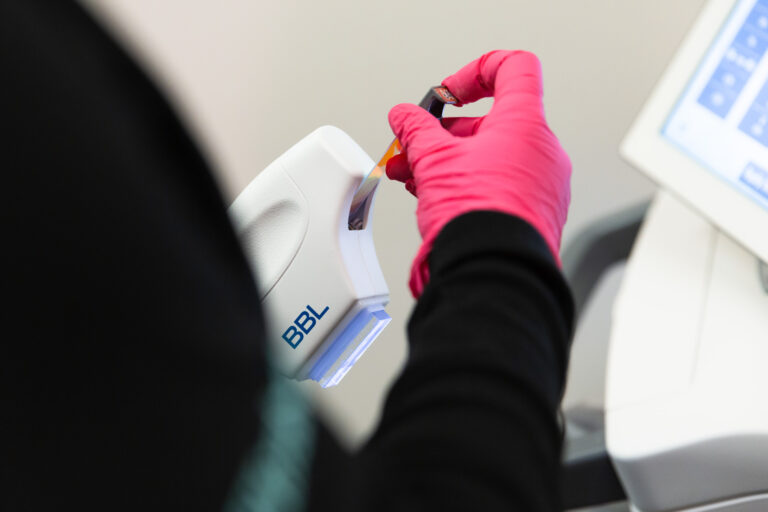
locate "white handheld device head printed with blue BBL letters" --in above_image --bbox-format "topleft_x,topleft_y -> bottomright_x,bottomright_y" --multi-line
229,126 -> 390,387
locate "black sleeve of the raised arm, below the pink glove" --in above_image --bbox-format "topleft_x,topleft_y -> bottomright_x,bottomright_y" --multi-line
344,212 -> 573,512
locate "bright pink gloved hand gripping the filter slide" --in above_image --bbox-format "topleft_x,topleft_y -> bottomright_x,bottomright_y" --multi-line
386,51 -> 571,298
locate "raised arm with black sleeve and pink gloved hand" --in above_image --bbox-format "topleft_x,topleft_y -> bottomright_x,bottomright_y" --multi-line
344,51 -> 573,511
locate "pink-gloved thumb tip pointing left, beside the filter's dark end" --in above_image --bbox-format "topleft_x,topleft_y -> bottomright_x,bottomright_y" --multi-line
389,103 -> 453,156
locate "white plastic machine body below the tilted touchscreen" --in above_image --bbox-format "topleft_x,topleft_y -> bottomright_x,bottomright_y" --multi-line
606,192 -> 768,512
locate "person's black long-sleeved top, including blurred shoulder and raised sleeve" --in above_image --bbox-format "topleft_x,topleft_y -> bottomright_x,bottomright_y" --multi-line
0,1 -> 573,511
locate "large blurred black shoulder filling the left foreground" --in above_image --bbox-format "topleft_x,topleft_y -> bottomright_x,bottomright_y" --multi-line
0,0 -> 265,511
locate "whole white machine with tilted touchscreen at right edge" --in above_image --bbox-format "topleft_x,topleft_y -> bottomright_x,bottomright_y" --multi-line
606,0 -> 768,512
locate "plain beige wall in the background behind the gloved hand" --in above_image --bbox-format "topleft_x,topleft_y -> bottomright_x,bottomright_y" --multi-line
86,0 -> 704,440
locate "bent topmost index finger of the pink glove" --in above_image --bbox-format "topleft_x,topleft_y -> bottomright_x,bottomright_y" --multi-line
443,50 -> 542,118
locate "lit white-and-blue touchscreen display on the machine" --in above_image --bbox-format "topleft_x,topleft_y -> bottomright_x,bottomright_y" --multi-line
662,0 -> 768,209
